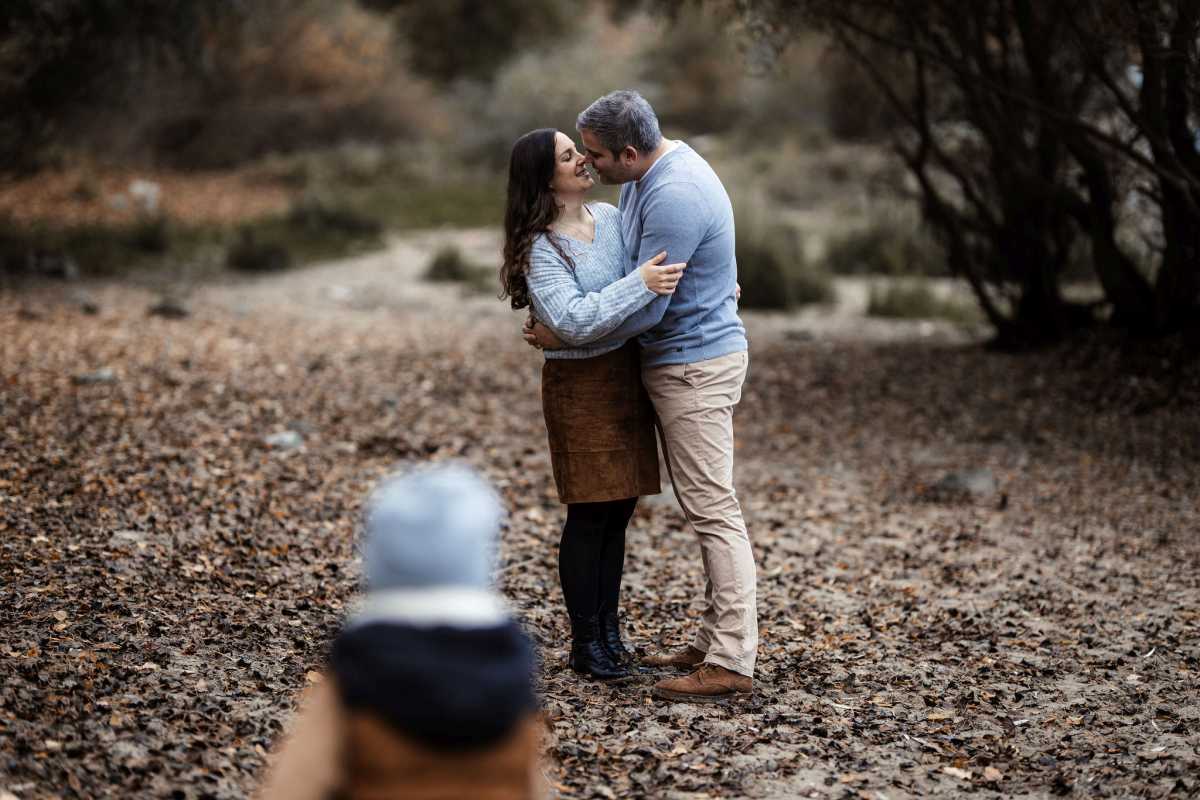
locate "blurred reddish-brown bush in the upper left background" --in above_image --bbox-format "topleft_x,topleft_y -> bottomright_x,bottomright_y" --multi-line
152,0 -> 450,167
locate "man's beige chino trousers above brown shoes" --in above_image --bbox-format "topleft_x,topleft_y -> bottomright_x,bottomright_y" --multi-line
642,351 -> 758,675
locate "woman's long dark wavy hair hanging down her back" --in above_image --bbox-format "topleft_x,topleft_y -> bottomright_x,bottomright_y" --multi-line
500,128 -> 572,308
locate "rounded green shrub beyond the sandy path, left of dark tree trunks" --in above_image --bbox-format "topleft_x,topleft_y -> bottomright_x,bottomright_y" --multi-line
824,221 -> 948,276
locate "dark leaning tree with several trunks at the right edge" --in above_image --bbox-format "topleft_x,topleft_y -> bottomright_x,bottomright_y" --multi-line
729,0 -> 1200,347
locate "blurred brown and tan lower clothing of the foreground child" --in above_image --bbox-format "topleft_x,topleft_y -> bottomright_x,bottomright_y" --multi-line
258,679 -> 546,800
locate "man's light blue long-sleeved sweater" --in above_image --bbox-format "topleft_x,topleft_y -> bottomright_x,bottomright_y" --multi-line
592,142 -> 746,366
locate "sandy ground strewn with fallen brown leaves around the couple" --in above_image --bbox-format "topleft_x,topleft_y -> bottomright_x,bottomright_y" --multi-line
0,245 -> 1200,800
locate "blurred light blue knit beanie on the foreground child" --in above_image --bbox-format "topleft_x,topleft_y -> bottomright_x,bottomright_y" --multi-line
362,464 -> 504,591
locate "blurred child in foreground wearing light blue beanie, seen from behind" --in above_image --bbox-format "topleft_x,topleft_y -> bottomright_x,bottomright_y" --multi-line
259,467 -> 544,800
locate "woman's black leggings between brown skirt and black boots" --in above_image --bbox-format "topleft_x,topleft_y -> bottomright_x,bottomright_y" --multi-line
558,498 -> 637,618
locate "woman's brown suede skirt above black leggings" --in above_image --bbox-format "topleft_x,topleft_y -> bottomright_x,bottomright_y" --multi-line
541,342 -> 662,503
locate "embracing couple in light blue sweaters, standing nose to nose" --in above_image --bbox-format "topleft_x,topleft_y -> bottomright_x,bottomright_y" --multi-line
500,91 -> 758,702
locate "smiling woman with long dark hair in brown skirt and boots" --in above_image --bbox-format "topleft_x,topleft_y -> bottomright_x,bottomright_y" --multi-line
500,128 -> 685,681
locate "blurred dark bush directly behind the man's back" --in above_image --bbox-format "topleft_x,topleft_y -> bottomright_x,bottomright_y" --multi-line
737,228 -> 833,311
